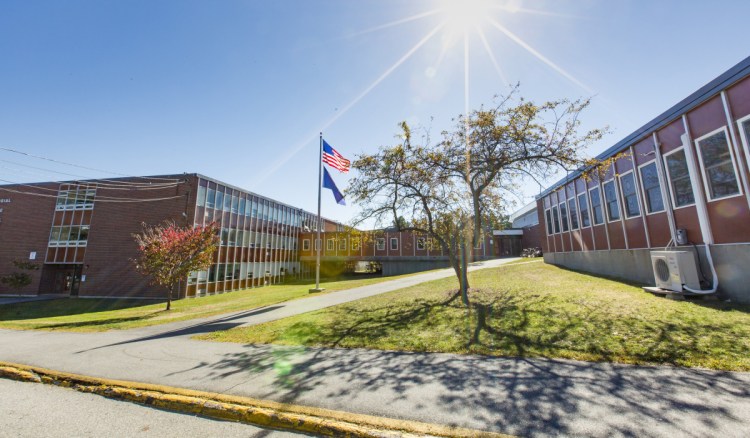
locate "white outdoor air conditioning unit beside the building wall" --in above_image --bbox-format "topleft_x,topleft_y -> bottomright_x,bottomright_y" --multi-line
651,251 -> 701,292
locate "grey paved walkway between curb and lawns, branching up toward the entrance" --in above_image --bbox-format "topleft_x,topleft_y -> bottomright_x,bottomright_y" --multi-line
0,258 -> 750,437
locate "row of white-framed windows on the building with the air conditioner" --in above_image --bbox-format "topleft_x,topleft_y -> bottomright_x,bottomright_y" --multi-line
545,117 -> 750,235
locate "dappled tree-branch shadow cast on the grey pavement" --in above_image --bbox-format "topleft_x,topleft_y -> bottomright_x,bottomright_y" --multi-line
189,346 -> 750,436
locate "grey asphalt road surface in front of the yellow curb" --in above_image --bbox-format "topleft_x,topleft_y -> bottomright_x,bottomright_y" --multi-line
0,379 -> 304,438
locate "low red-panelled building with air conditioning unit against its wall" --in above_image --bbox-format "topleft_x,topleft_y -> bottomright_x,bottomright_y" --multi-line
537,58 -> 750,302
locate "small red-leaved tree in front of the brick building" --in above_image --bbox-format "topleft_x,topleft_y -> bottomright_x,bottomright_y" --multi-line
133,221 -> 219,310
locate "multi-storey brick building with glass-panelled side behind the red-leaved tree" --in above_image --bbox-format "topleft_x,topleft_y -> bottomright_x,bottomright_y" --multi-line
0,174 -> 340,298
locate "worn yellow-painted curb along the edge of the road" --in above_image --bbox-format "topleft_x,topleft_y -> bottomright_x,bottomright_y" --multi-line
0,361 -> 508,438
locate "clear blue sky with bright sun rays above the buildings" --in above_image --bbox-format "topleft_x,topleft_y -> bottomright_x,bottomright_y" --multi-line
0,0 -> 750,226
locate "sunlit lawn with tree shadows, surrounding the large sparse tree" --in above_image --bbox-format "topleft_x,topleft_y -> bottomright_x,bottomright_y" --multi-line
200,262 -> 750,371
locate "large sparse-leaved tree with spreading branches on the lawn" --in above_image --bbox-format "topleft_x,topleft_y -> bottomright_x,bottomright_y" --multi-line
347,89 -> 605,306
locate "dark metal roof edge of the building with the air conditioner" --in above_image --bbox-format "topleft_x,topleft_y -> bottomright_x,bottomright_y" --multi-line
536,56 -> 750,199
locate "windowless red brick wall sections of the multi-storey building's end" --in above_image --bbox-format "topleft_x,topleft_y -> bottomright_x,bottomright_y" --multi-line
0,175 -> 197,297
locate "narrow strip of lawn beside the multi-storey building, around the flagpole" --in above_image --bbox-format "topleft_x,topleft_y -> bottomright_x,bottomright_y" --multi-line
0,274 -> 424,332
